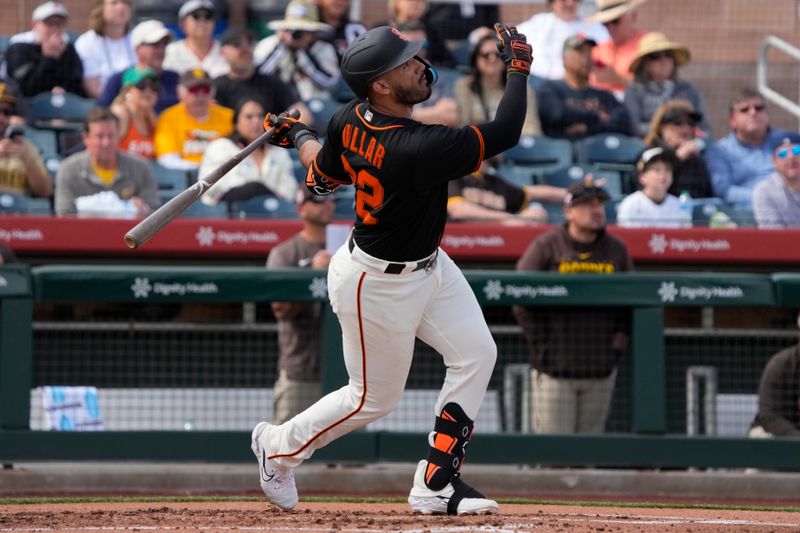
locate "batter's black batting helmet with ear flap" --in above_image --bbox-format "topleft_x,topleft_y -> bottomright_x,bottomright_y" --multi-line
341,26 -> 438,100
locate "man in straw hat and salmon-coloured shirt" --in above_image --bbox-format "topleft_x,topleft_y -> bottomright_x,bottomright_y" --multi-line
587,0 -> 647,100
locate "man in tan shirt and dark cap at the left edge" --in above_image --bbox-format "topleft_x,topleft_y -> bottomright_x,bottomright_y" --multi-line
0,83 -> 53,197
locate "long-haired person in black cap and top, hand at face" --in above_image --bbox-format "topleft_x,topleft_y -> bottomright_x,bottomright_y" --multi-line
644,100 -> 714,198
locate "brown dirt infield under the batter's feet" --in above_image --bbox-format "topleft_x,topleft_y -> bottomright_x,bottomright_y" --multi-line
0,501 -> 800,533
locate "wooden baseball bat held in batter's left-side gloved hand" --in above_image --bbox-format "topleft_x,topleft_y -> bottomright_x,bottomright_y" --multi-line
125,109 -> 300,248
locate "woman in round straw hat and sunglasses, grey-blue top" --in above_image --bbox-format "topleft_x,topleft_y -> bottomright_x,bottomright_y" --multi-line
625,32 -> 711,137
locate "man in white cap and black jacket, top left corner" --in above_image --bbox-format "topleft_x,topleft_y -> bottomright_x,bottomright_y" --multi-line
6,1 -> 86,96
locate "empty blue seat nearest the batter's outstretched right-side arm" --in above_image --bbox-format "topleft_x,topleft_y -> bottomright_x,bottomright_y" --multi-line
498,135 -> 572,185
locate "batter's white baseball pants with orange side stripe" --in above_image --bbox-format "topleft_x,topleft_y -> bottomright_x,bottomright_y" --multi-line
268,239 -> 497,467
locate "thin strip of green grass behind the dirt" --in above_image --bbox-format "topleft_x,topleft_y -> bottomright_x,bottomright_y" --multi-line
0,496 -> 800,513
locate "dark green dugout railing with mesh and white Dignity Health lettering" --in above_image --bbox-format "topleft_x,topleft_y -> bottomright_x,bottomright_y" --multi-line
0,266 -> 800,468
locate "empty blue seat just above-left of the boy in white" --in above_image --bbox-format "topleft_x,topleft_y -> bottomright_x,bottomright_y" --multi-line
575,133 -> 645,194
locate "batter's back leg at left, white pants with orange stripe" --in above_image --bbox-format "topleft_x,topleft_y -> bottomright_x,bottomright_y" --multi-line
253,241 -> 436,508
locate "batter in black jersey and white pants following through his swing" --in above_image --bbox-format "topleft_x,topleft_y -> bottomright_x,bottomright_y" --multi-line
251,24 -> 531,515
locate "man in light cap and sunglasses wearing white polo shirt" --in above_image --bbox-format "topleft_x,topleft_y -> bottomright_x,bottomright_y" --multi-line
164,0 -> 228,78
